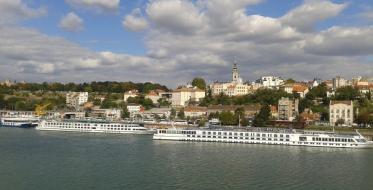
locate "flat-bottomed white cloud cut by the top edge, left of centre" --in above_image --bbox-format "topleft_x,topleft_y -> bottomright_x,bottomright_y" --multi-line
65,0 -> 120,13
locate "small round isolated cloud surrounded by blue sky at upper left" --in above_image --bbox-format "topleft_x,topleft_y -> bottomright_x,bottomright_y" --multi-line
58,12 -> 84,32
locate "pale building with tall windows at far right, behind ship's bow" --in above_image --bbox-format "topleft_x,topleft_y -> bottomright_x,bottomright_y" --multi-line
329,100 -> 354,126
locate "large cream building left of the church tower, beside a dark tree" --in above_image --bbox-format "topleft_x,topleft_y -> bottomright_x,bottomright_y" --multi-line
171,87 -> 205,107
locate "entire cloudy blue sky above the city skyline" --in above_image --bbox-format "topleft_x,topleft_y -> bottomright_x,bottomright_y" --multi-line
0,0 -> 373,86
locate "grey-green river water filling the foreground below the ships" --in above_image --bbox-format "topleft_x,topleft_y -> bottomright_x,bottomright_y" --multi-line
0,128 -> 373,190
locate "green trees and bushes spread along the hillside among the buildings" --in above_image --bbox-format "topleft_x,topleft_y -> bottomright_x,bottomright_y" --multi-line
0,78 -> 373,130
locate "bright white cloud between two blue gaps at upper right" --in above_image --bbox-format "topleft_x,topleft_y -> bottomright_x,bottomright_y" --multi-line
280,0 -> 347,32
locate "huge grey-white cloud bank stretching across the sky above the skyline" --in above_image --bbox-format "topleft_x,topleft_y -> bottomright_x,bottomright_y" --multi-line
0,0 -> 373,86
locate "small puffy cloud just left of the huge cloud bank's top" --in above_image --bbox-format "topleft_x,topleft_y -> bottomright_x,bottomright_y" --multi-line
122,9 -> 148,31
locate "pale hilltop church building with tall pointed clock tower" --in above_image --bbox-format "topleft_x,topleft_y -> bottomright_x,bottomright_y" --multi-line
210,64 -> 253,96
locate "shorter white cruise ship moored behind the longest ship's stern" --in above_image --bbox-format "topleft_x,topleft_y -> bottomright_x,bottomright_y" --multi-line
36,120 -> 155,134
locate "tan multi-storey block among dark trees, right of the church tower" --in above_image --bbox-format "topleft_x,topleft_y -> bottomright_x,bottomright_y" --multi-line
277,97 -> 299,121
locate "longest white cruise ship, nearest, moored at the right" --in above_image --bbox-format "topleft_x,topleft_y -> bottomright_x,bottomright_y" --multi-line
153,128 -> 373,148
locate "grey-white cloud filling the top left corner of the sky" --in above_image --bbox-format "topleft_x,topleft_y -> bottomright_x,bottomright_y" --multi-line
0,0 -> 47,24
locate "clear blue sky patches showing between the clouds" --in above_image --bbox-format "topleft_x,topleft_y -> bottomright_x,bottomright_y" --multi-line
19,0 -> 373,55
